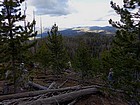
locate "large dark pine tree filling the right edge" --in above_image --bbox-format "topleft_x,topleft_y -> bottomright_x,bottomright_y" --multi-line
107,0 -> 140,103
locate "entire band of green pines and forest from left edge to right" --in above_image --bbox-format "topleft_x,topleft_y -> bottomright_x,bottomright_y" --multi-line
0,0 -> 140,105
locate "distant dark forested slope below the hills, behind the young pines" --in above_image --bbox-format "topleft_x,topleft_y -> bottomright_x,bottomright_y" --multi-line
64,33 -> 113,60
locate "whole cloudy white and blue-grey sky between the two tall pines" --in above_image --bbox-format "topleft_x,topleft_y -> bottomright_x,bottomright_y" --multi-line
26,0 -> 122,28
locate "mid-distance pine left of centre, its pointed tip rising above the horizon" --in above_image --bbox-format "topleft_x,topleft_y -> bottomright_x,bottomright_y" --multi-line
47,24 -> 68,74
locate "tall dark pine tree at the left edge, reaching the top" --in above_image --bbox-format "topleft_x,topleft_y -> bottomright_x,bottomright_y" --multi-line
0,0 -> 36,92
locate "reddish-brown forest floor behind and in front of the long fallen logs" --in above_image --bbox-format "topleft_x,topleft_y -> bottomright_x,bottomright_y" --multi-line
0,69 -> 128,105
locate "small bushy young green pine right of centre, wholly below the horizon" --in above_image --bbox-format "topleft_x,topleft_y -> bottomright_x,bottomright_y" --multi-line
74,42 -> 93,80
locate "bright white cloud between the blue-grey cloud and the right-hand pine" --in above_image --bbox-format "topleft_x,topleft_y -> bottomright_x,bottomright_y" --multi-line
65,0 -> 111,25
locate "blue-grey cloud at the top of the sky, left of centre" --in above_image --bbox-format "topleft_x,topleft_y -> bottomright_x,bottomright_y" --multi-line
28,0 -> 71,16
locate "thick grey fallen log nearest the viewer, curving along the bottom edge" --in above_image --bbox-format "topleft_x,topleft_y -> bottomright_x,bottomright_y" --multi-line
21,88 -> 98,105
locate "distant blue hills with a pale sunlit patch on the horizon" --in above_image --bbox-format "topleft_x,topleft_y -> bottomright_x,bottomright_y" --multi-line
37,26 -> 116,37
